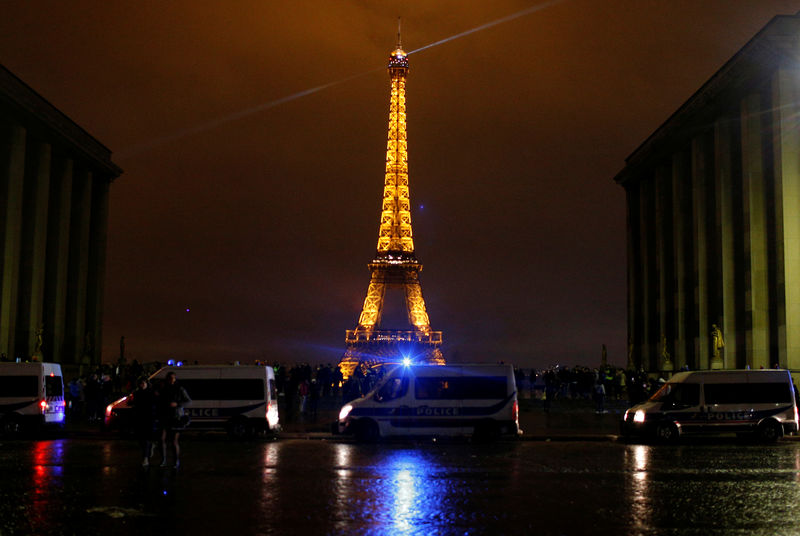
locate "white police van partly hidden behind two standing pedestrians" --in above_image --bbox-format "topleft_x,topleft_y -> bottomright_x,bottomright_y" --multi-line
105,365 -> 280,438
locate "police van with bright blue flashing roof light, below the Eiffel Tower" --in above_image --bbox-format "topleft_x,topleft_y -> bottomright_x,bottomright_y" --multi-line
338,365 -> 521,441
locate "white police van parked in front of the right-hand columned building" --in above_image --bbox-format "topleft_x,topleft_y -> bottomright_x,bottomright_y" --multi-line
621,369 -> 798,442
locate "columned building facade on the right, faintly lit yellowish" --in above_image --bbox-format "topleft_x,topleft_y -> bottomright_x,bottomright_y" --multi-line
615,14 -> 800,371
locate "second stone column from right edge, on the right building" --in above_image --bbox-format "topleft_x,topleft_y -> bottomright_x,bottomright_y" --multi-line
741,94 -> 771,368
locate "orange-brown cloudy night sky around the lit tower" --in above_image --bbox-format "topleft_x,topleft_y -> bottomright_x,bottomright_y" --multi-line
0,0 -> 800,368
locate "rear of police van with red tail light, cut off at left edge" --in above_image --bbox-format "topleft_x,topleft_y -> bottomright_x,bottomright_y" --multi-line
0,363 -> 66,437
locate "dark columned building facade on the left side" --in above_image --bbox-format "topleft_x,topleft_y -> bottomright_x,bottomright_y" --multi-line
0,66 -> 122,365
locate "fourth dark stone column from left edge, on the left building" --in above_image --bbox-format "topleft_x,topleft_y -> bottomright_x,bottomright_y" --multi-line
64,170 -> 94,365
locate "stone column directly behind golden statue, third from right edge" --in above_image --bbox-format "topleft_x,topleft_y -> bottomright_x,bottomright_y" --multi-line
714,118 -> 738,368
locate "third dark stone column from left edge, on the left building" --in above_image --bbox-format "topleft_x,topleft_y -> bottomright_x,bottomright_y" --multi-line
44,156 -> 73,363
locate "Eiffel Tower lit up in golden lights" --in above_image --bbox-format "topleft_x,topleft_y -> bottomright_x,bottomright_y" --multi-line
339,32 -> 445,378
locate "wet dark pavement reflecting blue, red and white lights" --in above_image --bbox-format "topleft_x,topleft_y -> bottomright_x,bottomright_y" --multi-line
0,438 -> 800,536
